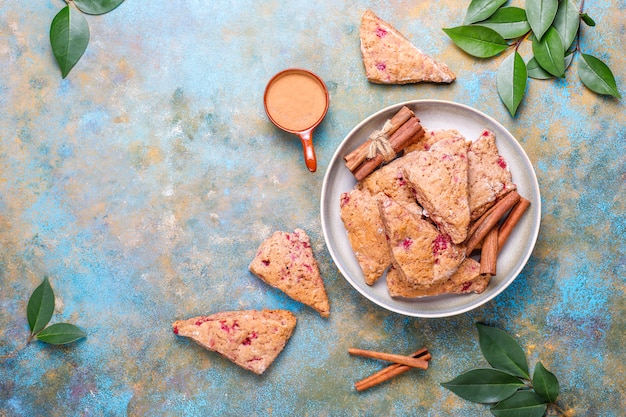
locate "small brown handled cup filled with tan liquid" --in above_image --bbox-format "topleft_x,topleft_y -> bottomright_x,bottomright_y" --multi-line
263,68 -> 329,172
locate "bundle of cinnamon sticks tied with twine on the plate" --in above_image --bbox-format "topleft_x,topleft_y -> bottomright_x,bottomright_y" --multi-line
343,106 -> 424,181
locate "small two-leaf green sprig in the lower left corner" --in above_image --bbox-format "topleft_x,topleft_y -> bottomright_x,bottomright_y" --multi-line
0,277 -> 87,359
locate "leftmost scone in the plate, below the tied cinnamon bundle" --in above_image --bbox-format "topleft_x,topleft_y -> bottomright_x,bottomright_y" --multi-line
340,189 -> 391,285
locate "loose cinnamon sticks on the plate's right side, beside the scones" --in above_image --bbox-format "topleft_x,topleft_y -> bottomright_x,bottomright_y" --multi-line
465,190 -> 530,276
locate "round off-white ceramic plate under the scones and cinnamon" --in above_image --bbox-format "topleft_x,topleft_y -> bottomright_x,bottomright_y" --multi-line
321,100 -> 541,317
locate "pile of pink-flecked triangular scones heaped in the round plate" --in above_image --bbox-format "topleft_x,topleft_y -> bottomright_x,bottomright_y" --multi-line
340,129 -> 516,298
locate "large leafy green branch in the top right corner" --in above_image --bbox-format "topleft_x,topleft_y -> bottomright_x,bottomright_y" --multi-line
443,0 -> 621,116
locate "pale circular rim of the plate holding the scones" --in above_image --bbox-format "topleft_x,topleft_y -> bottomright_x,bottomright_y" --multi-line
320,99 -> 541,318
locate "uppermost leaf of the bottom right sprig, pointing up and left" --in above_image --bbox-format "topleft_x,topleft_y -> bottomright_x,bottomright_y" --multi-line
476,322 -> 529,378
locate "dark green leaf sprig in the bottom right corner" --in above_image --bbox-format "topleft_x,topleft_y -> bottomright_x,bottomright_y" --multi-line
441,323 -> 565,417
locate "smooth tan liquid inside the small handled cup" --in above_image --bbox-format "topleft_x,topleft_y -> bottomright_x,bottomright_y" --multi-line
265,72 -> 327,132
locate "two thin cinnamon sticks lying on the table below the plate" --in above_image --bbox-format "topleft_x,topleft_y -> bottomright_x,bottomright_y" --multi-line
348,348 -> 431,391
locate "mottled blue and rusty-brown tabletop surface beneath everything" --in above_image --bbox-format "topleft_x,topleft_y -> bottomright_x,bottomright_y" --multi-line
0,0 -> 626,417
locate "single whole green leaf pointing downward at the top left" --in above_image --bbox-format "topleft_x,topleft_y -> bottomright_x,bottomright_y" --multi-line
50,6 -> 89,78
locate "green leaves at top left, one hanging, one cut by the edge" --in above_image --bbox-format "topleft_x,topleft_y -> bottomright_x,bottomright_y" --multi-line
50,0 -> 124,78
